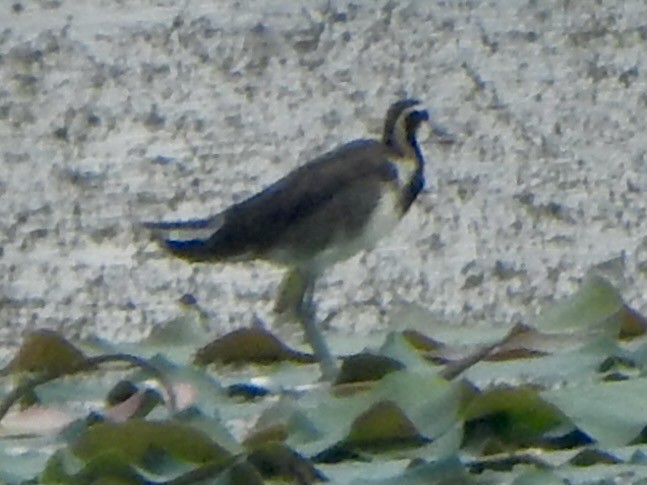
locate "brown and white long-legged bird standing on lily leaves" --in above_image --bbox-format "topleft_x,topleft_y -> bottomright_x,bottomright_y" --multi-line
144,98 -> 454,377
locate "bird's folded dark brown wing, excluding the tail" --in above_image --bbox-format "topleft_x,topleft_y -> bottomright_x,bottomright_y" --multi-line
204,140 -> 397,259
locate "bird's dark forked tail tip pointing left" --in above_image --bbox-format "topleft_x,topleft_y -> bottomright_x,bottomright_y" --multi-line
142,216 -> 222,262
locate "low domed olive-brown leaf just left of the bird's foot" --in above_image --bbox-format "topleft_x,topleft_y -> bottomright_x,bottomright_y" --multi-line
194,327 -> 314,366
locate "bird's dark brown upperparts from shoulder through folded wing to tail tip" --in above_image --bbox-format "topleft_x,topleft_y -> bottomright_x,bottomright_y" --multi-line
146,139 -> 398,264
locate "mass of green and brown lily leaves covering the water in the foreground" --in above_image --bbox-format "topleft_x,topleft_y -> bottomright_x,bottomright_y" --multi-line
0,277 -> 647,484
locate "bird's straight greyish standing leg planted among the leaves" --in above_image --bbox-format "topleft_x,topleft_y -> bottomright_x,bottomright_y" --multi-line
296,275 -> 337,381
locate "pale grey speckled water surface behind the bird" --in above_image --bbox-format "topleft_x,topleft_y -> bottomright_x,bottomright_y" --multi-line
0,0 -> 647,344
